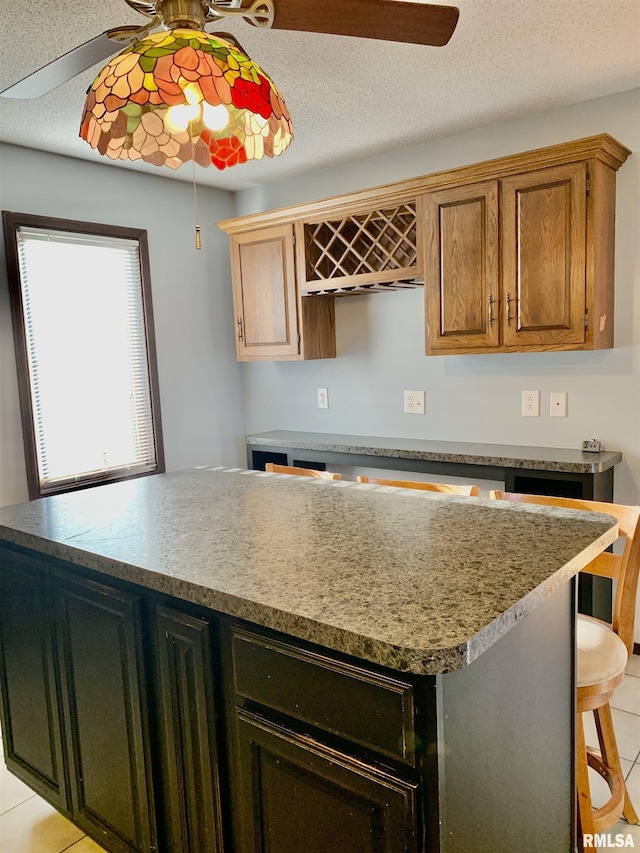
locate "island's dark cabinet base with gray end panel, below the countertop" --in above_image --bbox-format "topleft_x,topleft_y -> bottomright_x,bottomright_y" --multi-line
0,544 -> 575,853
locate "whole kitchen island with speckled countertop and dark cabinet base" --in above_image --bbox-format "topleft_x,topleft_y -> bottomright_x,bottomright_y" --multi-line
0,468 -> 616,853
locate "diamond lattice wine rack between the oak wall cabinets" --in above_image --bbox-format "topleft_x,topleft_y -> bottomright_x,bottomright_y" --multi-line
304,203 -> 418,290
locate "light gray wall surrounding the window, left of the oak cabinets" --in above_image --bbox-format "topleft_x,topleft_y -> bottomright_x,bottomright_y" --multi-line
0,145 -> 244,506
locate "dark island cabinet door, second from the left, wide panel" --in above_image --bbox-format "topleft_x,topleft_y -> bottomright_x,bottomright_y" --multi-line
54,573 -> 155,853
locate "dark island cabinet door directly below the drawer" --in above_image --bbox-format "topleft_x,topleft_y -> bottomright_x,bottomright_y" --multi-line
232,711 -> 417,853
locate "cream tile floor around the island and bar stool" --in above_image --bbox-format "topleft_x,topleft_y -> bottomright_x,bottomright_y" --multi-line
0,655 -> 640,853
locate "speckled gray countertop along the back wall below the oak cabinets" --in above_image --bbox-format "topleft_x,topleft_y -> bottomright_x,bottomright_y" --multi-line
246,430 -> 622,474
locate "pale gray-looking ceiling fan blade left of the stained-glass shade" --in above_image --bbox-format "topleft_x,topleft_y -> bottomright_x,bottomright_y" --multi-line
0,28 -> 122,98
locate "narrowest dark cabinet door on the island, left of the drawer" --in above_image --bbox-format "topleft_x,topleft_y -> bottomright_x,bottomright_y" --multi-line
155,607 -> 223,853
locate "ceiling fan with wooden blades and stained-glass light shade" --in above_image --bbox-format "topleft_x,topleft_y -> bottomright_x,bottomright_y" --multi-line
0,0 -> 459,183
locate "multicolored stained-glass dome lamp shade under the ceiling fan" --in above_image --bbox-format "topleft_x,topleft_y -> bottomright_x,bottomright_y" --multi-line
80,29 -> 293,169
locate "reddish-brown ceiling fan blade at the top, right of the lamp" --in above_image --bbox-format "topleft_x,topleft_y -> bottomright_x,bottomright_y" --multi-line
273,0 -> 460,47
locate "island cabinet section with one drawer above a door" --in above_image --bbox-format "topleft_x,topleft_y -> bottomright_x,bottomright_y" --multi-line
223,625 -> 424,853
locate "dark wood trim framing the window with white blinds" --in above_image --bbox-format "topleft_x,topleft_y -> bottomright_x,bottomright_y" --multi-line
2,211 -> 165,500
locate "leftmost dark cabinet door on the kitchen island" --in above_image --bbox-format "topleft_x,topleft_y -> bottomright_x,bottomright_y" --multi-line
0,549 -> 68,811
